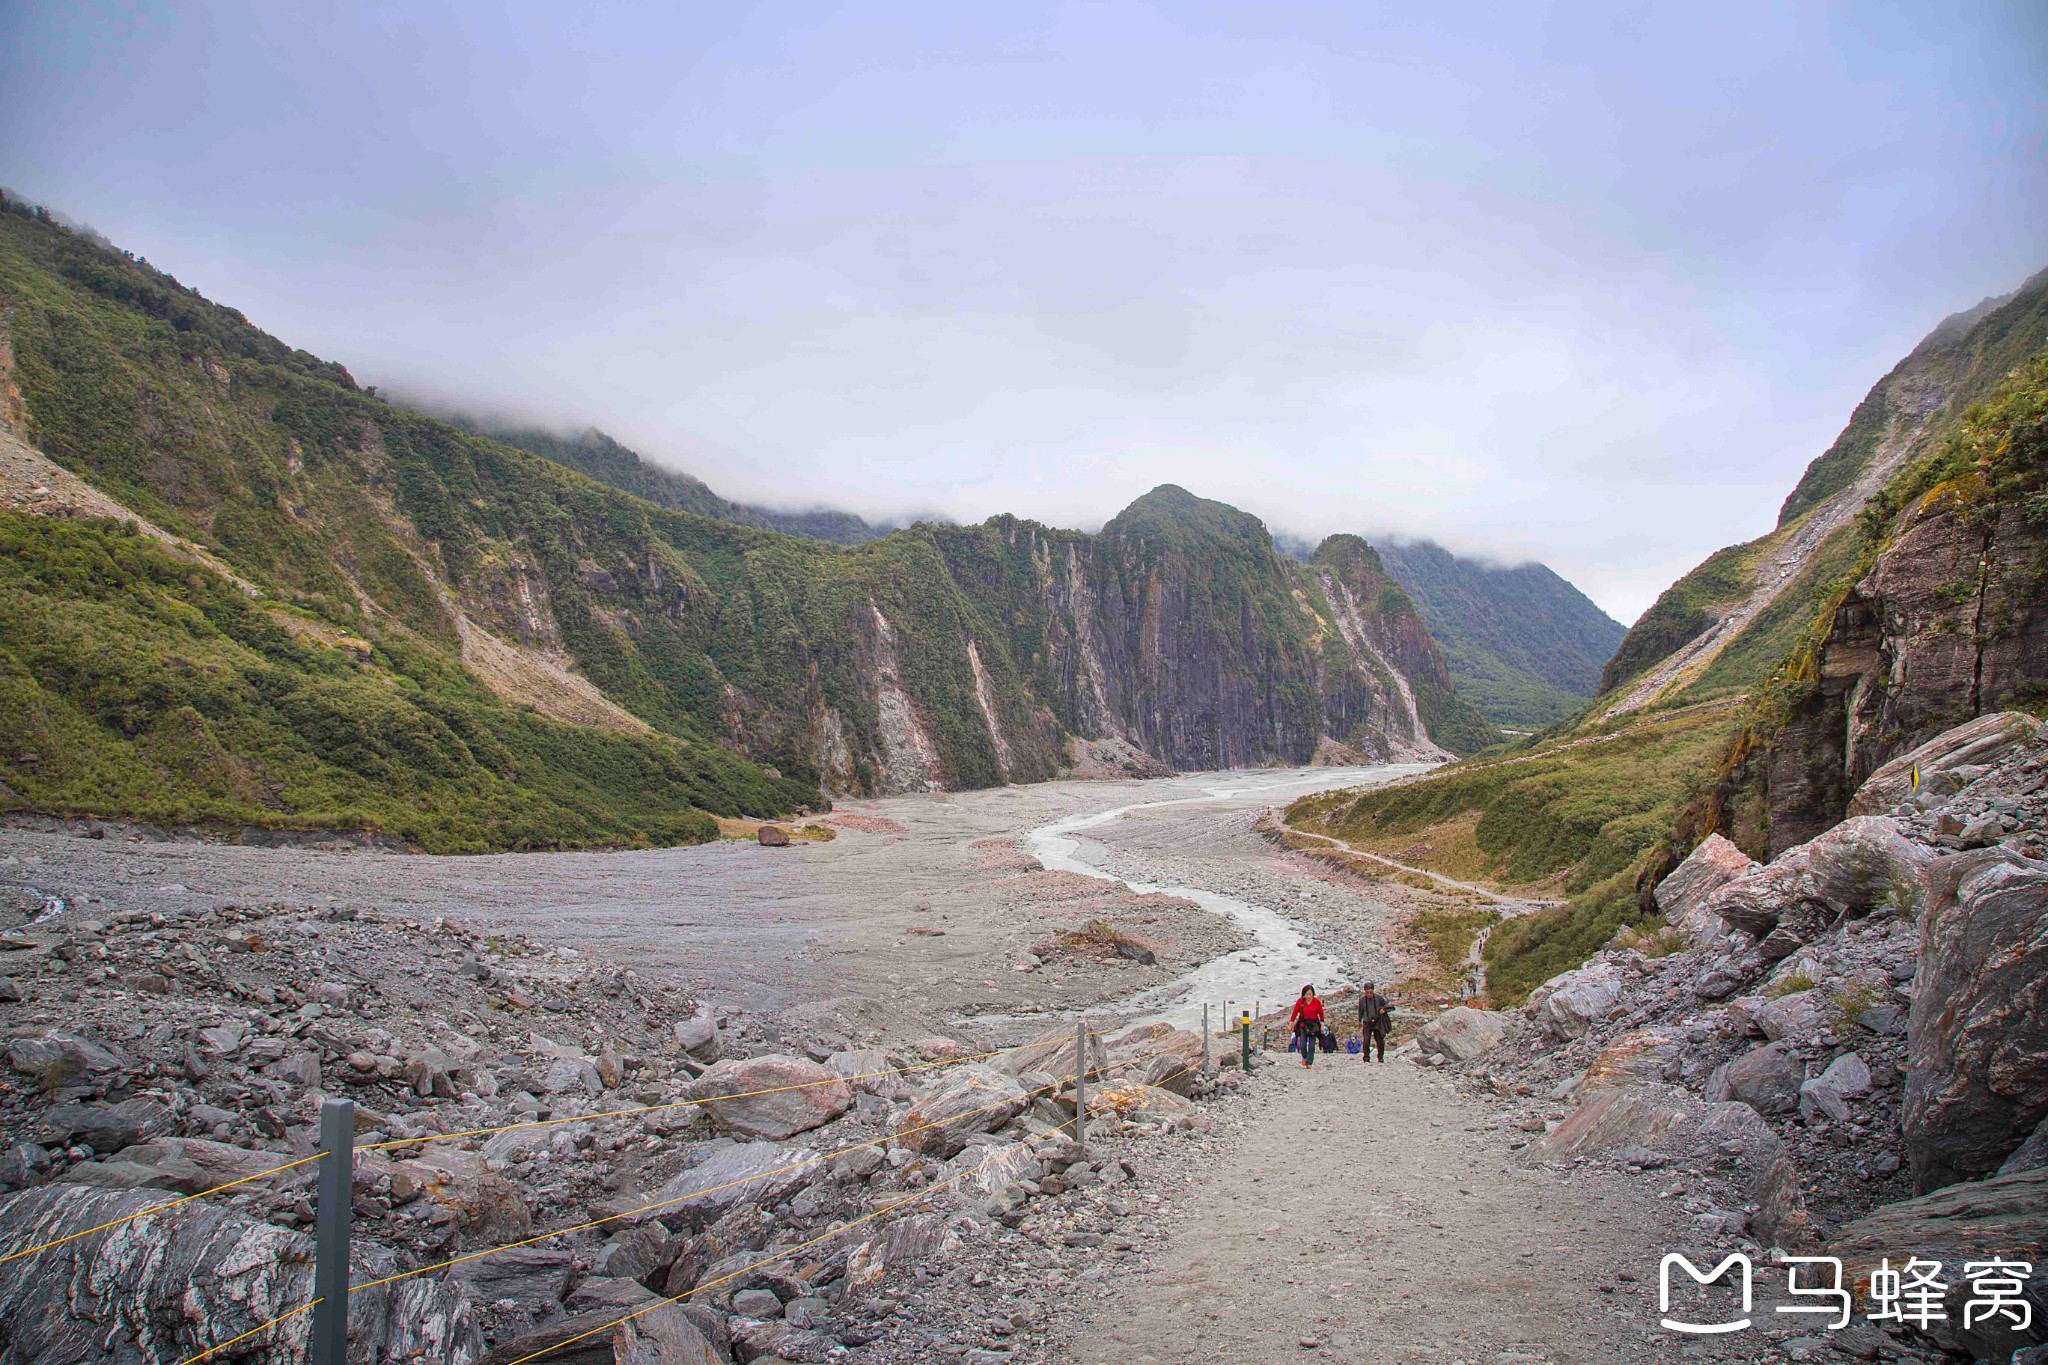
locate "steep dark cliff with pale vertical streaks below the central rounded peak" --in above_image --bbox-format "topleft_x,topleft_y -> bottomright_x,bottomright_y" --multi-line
934,485 -> 1487,769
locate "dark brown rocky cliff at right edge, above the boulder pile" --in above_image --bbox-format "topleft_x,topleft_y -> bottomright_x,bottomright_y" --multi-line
1743,354 -> 2048,851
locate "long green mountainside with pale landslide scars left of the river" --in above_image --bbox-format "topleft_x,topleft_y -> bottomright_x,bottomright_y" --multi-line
0,203 -> 1491,851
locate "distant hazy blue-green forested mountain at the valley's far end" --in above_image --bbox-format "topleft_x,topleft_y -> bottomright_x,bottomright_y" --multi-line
1378,540 -> 1626,729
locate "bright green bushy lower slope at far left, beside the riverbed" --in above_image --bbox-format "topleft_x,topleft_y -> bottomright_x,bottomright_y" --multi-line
0,514 -> 803,853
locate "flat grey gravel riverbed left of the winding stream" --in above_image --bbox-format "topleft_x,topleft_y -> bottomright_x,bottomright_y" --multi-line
0,769 -> 1417,1036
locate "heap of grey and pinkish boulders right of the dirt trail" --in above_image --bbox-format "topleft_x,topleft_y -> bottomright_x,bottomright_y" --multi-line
1417,712 -> 2048,1361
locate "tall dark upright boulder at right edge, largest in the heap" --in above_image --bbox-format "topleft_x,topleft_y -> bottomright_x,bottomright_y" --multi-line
1901,849 -> 2048,1193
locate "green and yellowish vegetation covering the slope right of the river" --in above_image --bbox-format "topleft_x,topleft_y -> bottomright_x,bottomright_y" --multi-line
1288,274 -> 2048,1003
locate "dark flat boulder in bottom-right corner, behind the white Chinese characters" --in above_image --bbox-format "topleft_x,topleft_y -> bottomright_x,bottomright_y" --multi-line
1827,1169 -> 2048,1361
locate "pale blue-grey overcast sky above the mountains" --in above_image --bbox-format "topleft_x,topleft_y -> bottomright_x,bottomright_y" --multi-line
0,0 -> 2048,622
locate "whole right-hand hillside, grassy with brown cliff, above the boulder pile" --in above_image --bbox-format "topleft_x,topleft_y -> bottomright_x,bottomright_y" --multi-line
1288,274 -> 2048,1003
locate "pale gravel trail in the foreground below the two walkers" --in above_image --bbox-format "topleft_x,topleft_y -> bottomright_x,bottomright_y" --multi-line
1057,1054 -> 1761,1365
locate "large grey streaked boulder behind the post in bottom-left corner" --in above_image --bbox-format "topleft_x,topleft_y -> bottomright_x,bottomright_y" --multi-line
0,1185 -> 483,1365
